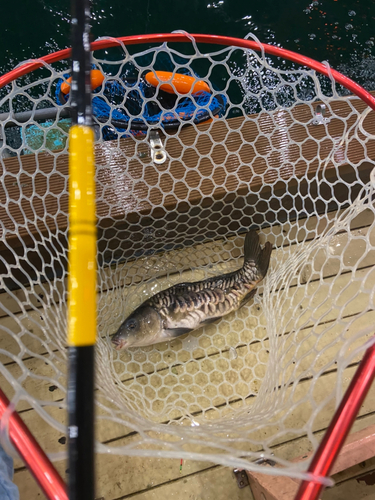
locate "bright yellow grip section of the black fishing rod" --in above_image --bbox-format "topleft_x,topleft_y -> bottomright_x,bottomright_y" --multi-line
68,125 -> 96,346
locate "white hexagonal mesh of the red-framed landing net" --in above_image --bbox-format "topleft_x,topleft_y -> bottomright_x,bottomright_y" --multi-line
0,35 -> 375,477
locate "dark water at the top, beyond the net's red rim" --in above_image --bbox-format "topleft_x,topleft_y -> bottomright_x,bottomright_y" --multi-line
0,0 -> 375,90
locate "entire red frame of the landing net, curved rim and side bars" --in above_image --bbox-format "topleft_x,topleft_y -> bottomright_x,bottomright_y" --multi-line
0,33 -> 375,500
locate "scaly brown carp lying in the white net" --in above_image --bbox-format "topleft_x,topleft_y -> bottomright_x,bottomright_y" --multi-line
111,231 -> 272,351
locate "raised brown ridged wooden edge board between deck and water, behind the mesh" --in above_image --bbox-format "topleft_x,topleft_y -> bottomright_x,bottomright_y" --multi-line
0,93 -> 375,288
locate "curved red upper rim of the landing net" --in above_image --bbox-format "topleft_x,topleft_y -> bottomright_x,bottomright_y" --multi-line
0,33 -> 375,110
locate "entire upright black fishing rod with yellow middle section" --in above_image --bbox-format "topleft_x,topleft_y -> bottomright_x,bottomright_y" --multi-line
67,0 -> 97,500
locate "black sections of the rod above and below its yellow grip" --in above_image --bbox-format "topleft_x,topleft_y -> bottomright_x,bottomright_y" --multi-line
68,0 -> 95,500
